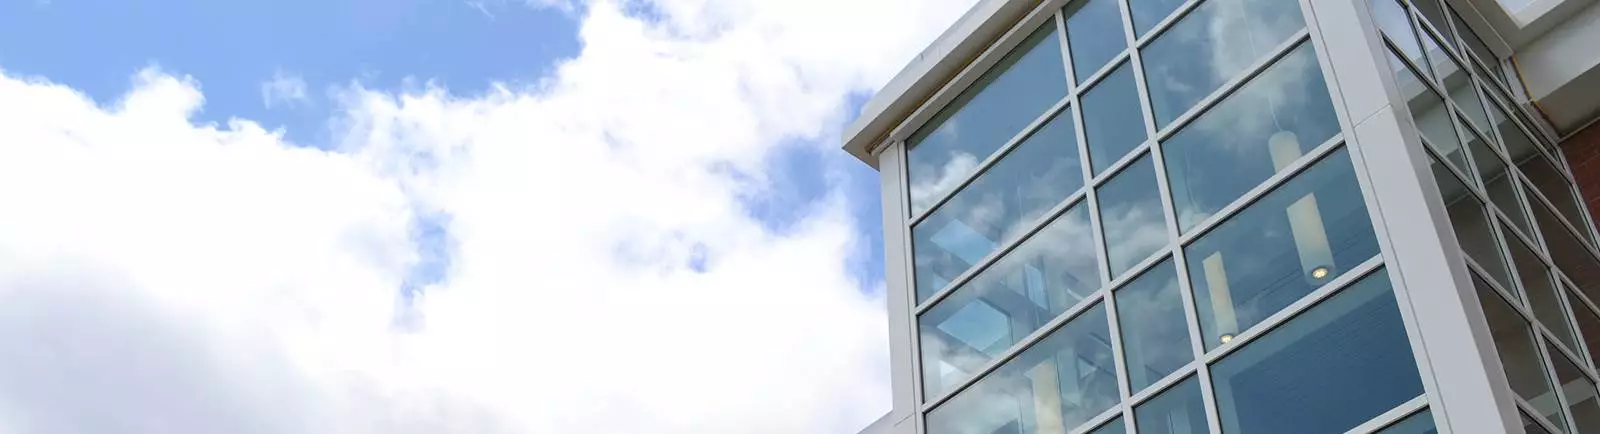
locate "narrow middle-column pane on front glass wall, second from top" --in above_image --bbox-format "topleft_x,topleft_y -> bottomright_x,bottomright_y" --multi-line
1083,62 -> 1146,175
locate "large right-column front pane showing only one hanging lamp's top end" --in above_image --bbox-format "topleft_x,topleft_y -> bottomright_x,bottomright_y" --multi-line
1162,43 -> 1339,232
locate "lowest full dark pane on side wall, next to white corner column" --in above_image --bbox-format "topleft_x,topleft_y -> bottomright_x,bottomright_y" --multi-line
1472,274 -> 1560,432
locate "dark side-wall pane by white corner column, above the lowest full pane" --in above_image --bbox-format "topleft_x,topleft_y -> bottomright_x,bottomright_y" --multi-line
1432,151 -> 1515,294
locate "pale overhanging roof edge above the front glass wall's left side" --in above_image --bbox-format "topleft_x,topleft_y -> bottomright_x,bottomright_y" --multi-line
843,0 -> 1040,168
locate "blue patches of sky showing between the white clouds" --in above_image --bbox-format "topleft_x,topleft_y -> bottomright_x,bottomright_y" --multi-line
0,0 -> 883,293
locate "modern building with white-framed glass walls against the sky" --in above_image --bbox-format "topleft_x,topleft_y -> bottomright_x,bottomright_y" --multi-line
845,0 -> 1600,434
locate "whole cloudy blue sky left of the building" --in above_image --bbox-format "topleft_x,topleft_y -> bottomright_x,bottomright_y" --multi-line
0,0 -> 973,434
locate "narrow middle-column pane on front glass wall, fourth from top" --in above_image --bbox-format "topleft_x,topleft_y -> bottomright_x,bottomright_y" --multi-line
1117,259 -> 1195,392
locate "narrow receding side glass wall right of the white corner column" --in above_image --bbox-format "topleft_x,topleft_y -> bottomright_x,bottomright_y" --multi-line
1370,0 -> 1600,432
